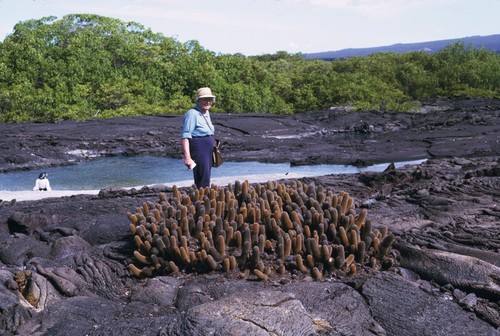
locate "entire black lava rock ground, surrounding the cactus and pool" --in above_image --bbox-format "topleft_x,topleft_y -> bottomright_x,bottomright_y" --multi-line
0,100 -> 500,336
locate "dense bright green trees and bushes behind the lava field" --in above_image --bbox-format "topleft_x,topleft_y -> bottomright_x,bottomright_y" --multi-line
0,14 -> 500,122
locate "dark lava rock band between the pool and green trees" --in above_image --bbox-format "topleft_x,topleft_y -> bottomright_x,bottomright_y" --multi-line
0,100 -> 500,172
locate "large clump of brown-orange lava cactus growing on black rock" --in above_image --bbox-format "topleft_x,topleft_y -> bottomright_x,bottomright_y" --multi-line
128,181 -> 394,281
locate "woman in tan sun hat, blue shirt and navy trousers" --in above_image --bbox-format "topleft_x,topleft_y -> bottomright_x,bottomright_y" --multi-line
181,87 -> 215,188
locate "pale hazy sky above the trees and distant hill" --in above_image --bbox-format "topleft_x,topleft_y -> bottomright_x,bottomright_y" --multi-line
0,0 -> 500,55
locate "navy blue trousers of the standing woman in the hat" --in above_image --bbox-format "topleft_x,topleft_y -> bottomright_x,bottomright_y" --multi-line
189,136 -> 215,188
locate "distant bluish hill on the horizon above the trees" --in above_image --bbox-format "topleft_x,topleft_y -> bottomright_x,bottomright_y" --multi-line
304,34 -> 500,60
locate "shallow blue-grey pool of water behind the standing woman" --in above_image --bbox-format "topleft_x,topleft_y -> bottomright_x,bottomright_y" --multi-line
0,156 -> 424,191
